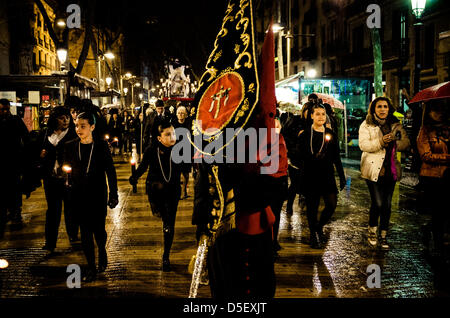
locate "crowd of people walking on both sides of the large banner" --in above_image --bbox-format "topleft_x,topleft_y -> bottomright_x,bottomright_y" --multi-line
0,94 -> 450,290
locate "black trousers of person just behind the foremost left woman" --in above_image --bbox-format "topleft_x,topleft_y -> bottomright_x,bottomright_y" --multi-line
44,177 -> 79,249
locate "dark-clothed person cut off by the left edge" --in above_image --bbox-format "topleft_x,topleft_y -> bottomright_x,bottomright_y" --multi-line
0,99 -> 29,238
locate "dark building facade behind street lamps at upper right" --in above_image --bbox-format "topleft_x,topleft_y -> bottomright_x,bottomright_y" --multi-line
256,0 -> 450,110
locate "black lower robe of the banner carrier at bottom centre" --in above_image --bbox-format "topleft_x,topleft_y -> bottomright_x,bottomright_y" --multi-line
208,229 -> 276,299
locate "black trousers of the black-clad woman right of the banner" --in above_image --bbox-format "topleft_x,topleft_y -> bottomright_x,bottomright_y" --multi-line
305,192 -> 337,233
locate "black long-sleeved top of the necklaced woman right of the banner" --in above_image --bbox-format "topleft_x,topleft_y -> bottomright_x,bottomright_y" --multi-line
298,128 -> 345,193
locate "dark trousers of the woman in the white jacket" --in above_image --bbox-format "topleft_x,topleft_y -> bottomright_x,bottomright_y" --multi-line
366,177 -> 395,231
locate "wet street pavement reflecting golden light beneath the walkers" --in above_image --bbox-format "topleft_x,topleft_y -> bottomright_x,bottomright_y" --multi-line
0,157 -> 450,298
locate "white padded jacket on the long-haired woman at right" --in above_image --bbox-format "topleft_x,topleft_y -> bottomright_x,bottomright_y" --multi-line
359,120 -> 409,182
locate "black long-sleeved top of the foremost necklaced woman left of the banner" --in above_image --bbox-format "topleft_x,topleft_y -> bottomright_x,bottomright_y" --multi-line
64,139 -> 117,215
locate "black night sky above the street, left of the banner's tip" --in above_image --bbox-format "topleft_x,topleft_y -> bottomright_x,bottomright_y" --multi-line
95,0 -> 228,82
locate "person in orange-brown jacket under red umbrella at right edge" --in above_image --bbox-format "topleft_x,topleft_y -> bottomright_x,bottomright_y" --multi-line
417,100 -> 450,257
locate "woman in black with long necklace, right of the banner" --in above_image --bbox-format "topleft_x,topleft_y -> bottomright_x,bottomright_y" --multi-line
299,104 -> 346,248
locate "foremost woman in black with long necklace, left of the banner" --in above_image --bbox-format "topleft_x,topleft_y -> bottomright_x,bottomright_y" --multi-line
64,112 -> 118,282
